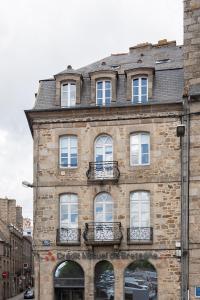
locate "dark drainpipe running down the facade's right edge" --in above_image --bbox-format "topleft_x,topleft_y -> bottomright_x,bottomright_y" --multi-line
181,97 -> 190,300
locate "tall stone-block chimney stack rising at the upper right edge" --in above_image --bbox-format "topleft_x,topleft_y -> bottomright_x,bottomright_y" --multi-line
184,0 -> 200,98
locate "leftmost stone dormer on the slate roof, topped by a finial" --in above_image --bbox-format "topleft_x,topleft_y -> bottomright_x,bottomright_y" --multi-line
54,66 -> 82,108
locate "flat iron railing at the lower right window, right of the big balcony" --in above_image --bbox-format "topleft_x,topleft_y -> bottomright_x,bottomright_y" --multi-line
127,227 -> 153,244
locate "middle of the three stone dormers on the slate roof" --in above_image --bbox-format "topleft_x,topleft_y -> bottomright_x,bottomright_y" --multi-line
89,70 -> 117,106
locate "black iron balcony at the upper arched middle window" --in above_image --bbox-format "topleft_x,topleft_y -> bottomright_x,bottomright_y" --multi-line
86,161 -> 120,181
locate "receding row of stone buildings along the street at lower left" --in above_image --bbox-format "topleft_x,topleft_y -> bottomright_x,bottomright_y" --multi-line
0,198 -> 33,300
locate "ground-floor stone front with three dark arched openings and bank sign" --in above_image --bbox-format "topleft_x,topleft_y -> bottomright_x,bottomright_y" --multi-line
35,250 -> 180,300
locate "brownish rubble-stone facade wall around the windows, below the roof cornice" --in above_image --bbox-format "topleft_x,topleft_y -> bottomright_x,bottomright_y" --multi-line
33,106 -> 181,300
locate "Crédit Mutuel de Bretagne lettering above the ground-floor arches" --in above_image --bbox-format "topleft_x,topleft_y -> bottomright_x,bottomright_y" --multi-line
57,251 -> 158,260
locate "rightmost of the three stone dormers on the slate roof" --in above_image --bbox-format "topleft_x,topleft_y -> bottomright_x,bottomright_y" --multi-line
125,68 -> 154,104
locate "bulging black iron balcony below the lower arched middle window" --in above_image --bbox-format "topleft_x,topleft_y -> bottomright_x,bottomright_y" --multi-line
83,222 -> 122,245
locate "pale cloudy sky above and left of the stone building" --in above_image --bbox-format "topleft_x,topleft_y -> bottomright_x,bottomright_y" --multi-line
0,0 -> 183,218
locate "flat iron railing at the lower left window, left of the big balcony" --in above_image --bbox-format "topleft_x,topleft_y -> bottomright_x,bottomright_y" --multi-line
56,228 -> 81,245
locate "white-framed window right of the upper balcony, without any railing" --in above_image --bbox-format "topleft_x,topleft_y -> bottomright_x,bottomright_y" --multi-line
130,132 -> 150,166
